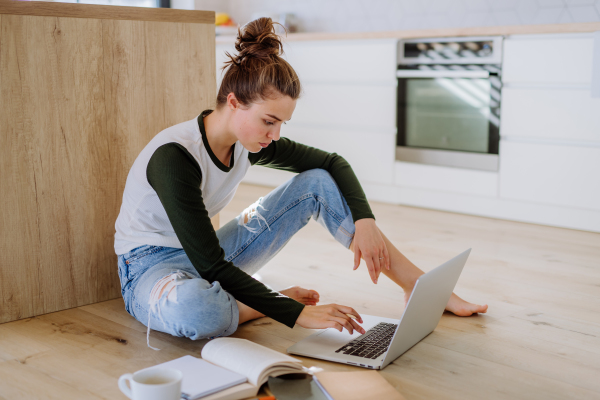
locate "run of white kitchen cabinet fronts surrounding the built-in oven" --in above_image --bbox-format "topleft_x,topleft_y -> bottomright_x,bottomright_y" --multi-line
216,33 -> 600,232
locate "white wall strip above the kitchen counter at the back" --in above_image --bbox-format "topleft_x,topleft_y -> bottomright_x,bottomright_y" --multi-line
219,0 -> 600,32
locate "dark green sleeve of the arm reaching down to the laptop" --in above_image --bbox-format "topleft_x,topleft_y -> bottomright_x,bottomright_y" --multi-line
146,143 -> 304,328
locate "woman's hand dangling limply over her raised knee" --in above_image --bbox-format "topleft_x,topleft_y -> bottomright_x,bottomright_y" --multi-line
354,218 -> 390,283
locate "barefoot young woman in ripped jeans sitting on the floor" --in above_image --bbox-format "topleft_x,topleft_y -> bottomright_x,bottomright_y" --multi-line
115,18 -> 487,345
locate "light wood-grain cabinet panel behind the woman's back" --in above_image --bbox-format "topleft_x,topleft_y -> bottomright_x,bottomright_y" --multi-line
0,7 -> 215,322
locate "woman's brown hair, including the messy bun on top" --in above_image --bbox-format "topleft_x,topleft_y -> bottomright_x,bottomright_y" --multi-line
216,18 -> 302,108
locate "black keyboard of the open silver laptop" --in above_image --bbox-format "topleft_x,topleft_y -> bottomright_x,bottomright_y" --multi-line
335,322 -> 398,359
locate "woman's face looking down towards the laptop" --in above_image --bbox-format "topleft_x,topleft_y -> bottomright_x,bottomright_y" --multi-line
228,93 -> 296,153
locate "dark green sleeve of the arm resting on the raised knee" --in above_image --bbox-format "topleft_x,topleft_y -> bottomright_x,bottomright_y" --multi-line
248,137 -> 375,222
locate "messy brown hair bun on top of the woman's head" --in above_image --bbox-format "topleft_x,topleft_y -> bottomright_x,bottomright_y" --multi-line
230,17 -> 287,66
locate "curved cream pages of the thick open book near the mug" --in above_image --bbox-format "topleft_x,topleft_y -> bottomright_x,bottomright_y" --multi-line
202,338 -> 302,386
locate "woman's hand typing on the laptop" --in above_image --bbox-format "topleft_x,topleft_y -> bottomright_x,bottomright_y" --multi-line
296,304 -> 365,334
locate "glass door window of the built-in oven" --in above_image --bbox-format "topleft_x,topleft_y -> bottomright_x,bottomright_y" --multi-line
398,77 -> 500,154
